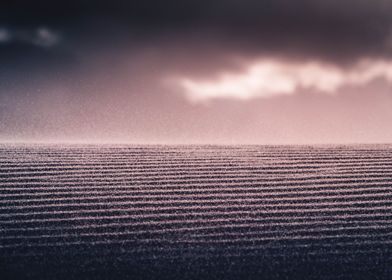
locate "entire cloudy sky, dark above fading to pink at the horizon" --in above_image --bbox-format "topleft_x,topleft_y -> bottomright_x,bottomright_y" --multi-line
0,0 -> 392,144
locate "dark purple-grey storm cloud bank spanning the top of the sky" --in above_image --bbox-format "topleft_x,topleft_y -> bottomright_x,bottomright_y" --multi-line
0,0 -> 392,95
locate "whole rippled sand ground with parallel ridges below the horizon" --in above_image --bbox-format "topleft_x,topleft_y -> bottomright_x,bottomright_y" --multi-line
0,144 -> 392,279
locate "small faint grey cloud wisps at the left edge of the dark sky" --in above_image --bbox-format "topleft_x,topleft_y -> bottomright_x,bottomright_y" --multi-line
0,27 -> 61,48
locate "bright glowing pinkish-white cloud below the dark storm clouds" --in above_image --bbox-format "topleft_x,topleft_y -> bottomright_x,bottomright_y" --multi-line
177,60 -> 392,102
